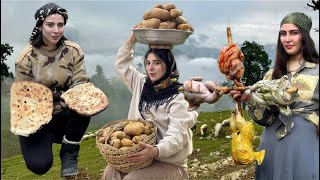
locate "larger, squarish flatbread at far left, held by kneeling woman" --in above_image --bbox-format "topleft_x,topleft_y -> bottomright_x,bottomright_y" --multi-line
10,81 -> 53,137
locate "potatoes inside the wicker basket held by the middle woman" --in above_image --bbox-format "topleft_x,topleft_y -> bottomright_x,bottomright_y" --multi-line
98,120 -> 155,150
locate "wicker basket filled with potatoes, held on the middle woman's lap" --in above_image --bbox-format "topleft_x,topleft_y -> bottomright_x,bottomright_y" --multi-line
96,119 -> 157,172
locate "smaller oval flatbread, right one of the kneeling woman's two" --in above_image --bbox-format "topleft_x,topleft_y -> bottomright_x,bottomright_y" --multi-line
61,82 -> 109,116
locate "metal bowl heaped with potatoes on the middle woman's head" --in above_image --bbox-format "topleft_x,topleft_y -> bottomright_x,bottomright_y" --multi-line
133,4 -> 194,47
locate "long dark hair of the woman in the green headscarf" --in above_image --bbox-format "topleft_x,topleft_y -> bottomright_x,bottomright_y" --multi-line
272,26 -> 319,79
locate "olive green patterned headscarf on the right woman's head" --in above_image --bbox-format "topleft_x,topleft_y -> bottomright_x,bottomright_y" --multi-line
280,12 -> 312,32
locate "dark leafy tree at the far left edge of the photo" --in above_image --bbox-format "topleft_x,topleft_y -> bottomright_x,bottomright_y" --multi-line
1,43 -> 13,82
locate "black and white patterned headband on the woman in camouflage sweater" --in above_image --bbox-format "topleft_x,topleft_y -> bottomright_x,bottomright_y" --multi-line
30,3 -> 68,41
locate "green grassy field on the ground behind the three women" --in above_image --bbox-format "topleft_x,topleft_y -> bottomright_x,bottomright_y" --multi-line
1,111 -> 262,180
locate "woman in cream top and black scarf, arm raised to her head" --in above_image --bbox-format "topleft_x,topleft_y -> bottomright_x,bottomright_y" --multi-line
102,26 -> 224,179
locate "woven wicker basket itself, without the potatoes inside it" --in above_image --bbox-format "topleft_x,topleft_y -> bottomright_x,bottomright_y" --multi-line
96,119 -> 157,172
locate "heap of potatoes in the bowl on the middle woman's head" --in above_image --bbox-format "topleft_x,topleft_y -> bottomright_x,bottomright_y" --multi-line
137,4 -> 194,32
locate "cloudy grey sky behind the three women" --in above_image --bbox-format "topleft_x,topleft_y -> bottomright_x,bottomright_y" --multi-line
1,0 -> 319,81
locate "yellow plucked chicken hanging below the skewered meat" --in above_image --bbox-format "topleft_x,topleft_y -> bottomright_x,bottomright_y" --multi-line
230,110 -> 265,165
